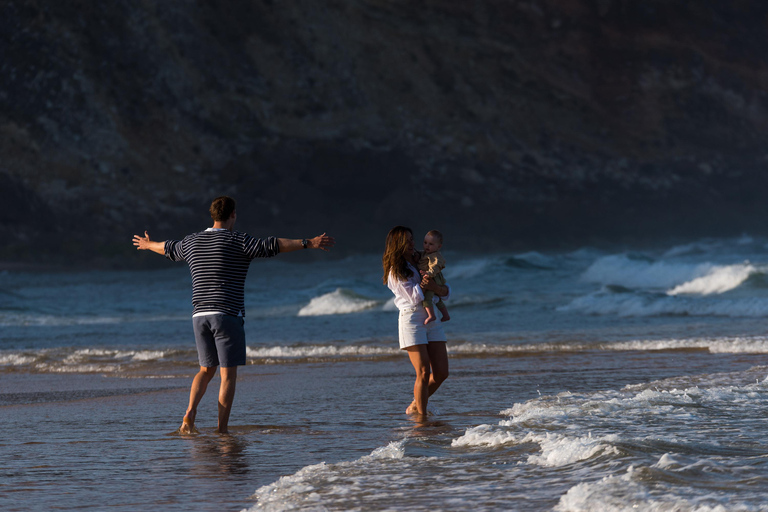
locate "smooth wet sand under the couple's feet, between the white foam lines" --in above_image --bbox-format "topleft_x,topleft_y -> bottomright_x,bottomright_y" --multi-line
0,352 -> 768,511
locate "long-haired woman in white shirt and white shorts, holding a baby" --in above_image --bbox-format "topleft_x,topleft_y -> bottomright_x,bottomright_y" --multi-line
381,226 -> 450,415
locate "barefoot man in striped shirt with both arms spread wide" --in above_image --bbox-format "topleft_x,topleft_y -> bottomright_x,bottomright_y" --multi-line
133,196 -> 335,434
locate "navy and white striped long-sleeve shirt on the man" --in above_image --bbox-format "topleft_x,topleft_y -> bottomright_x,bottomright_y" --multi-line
165,229 -> 280,316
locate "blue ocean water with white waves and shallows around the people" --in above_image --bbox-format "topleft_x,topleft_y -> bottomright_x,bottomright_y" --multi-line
0,236 -> 768,512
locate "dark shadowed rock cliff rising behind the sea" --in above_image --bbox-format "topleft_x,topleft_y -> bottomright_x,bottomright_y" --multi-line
0,0 -> 768,261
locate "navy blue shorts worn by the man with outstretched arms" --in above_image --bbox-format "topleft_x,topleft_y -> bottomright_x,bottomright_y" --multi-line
192,315 -> 245,368
